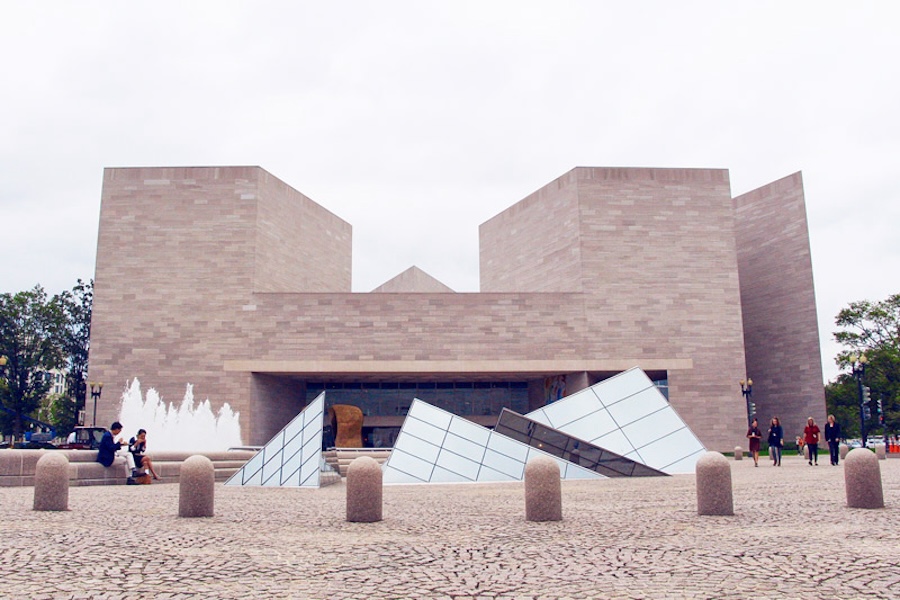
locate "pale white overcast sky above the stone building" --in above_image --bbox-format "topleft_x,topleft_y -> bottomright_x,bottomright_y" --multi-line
0,0 -> 900,379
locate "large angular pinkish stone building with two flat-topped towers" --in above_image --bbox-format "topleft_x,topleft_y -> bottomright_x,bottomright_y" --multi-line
90,167 -> 825,450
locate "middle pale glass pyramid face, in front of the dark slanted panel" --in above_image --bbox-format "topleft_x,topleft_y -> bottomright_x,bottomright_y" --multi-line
382,399 -> 603,483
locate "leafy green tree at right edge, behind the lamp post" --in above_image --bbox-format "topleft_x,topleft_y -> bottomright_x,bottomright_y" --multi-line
834,294 -> 900,433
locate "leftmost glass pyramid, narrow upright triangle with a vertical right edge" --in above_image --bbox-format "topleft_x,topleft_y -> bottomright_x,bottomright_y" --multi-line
225,392 -> 340,488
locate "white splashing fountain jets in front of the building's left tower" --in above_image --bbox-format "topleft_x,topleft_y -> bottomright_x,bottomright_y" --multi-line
119,378 -> 243,452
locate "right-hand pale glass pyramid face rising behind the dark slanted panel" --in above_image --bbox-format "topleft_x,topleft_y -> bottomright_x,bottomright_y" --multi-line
525,368 -> 706,475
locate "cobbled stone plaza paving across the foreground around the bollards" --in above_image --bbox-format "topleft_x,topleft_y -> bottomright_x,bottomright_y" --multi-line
0,455 -> 900,599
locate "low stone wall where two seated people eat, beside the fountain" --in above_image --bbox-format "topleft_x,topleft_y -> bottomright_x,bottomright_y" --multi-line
0,449 -> 256,487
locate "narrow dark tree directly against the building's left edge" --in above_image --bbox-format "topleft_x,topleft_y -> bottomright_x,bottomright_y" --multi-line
58,279 -> 94,431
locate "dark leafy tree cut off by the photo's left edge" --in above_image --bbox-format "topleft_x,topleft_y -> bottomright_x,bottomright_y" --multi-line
0,285 -> 66,438
